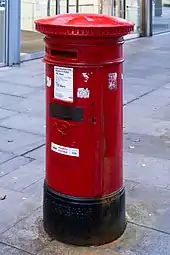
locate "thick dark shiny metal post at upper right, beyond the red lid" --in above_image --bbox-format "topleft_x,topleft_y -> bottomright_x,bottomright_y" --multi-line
140,0 -> 152,37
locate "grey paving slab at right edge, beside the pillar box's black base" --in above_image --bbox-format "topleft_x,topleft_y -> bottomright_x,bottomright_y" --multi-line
126,184 -> 170,235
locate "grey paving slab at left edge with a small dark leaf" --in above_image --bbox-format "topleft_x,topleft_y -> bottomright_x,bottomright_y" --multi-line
0,187 -> 42,235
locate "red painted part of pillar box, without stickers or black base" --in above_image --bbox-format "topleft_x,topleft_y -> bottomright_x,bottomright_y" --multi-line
36,14 -> 133,198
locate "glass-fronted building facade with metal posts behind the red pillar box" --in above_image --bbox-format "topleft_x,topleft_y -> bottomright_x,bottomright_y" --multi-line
0,0 -> 170,66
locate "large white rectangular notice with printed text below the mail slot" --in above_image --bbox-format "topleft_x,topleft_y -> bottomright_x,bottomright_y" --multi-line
54,66 -> 73,102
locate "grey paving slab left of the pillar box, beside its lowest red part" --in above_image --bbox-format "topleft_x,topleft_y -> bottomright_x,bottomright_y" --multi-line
0,160 -> 45,191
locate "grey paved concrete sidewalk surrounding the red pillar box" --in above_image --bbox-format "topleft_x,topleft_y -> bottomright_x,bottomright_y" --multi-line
0,34 -> 170,255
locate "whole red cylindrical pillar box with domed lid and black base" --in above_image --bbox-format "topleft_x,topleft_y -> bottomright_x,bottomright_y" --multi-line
35,14 -> 133,245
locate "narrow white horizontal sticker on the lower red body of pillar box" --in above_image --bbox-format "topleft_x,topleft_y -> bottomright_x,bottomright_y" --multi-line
51,143 -> 79,157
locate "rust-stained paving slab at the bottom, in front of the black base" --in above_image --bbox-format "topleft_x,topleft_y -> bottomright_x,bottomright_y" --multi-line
37,223 -> 170,255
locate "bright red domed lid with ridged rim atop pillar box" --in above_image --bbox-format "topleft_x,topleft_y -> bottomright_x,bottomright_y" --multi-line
35,13 -> 134,37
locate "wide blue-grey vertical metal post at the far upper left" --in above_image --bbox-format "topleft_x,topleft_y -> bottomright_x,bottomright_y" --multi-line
6,0 -> 21,66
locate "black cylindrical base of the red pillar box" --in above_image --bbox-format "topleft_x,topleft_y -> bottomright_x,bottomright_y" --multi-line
43,180 -> 126,246
